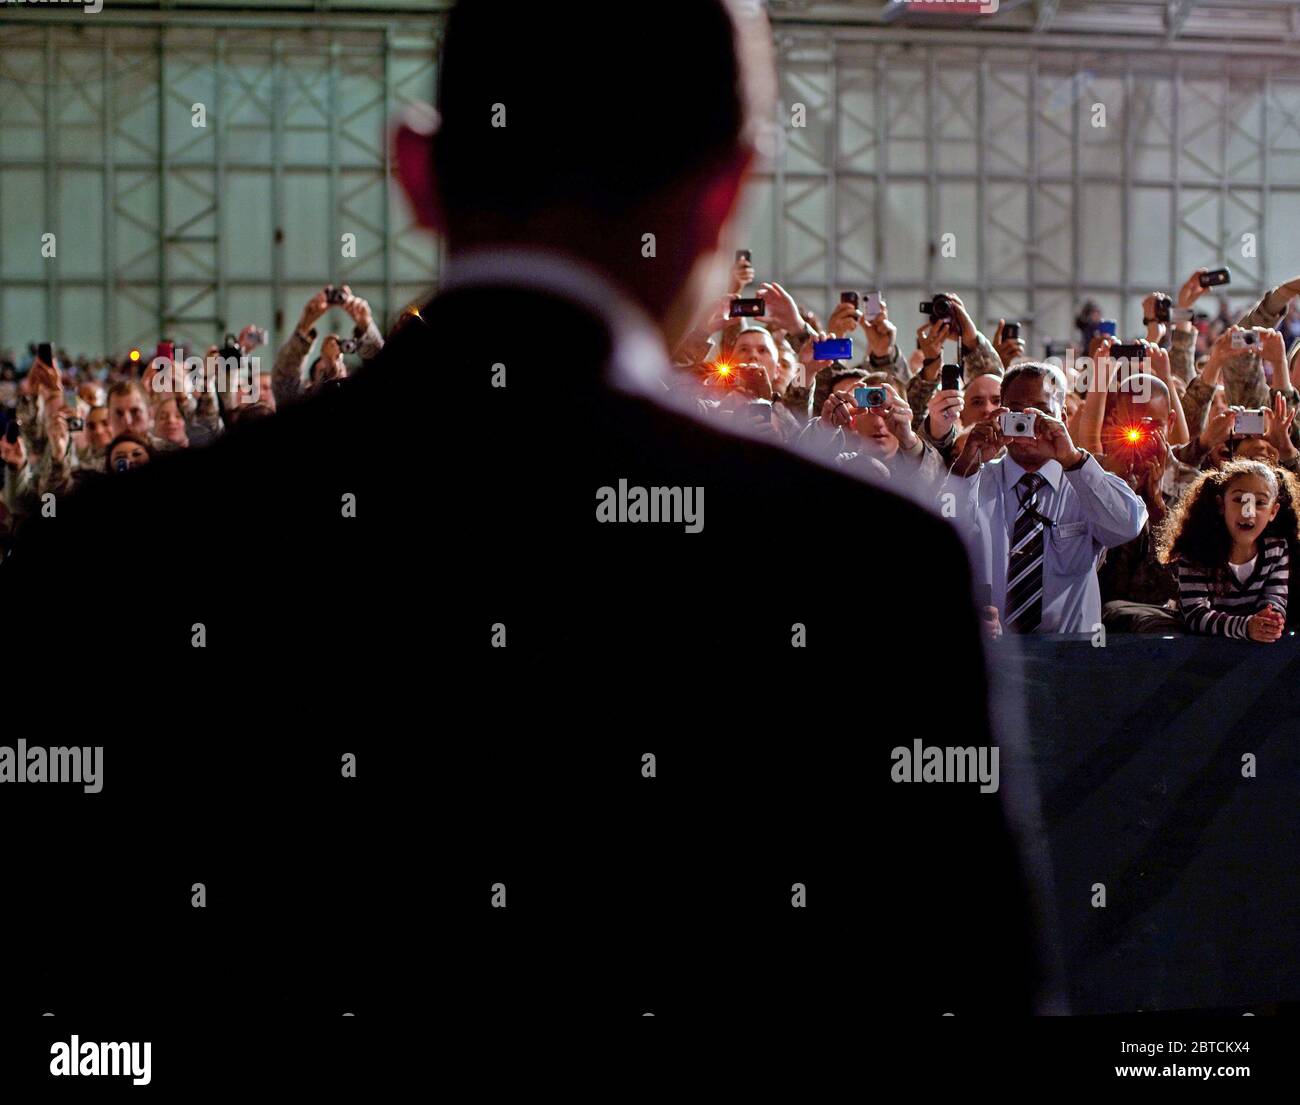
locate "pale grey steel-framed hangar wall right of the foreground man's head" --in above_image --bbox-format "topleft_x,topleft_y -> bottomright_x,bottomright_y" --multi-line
748,23 -> 1300,347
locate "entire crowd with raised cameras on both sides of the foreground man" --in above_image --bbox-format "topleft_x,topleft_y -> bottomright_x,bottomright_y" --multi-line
0,251 -> 1300,641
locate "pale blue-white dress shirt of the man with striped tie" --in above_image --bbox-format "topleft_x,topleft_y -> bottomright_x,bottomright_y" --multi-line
967,454 -> 1147,633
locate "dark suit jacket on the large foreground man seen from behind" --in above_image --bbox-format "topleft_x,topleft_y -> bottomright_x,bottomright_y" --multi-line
4,287 -> 1036,1017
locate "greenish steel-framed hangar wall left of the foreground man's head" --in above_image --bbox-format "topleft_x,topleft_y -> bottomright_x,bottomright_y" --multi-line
0,9 -> 439,352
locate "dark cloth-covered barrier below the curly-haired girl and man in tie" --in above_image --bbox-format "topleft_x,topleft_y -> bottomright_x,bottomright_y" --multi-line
1013,634 -> 1300,1014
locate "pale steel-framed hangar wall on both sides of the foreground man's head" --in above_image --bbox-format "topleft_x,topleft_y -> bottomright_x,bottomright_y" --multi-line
0,7 -> 1300,351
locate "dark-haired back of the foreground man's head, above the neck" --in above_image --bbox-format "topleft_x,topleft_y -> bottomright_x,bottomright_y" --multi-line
433,0 -> 772,228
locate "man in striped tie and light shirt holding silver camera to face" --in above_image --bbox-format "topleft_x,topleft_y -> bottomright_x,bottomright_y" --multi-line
957,363 -> 1147,633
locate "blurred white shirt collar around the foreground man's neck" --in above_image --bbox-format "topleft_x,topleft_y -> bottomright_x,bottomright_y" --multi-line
438,246 -> 670,394
